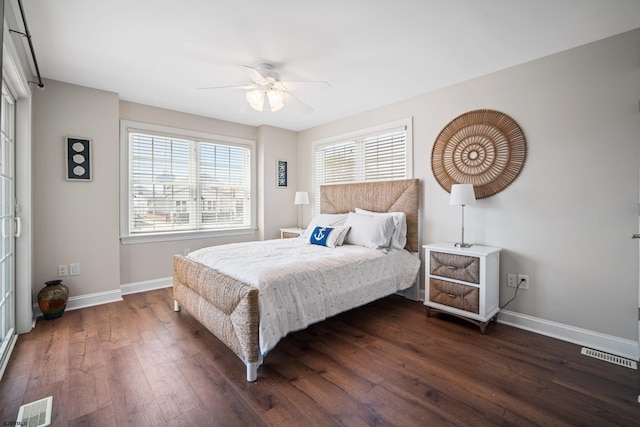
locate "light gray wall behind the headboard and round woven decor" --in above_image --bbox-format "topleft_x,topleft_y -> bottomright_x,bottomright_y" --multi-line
299,31 -> 640,341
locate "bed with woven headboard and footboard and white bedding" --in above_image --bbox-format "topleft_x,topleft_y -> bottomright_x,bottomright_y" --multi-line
173,179 -> 420,382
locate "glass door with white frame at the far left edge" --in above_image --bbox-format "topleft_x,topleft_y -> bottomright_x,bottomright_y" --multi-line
0,82 -> 20,376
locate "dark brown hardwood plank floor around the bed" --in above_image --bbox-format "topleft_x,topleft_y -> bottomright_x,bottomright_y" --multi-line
0,288 -> 640,426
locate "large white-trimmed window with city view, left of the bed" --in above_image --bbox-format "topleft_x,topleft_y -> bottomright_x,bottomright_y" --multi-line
121,122 -> 255,243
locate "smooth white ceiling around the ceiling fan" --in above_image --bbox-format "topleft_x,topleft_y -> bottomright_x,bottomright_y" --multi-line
14,0 -> 640,131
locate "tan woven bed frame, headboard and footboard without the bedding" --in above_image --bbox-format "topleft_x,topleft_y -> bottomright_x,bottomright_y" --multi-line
173,179 -> 420,382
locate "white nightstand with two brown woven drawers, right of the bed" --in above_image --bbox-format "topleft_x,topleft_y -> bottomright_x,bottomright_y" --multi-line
423,243 -> 501,334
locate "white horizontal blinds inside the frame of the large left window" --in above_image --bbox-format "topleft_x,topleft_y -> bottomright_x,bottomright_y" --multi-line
129,132 -> 251,235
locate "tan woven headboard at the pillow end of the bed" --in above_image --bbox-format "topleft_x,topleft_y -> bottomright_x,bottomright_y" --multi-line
320,179 -> 420,252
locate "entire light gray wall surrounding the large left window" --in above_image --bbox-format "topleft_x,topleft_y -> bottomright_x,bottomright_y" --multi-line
33,87 -> 297,297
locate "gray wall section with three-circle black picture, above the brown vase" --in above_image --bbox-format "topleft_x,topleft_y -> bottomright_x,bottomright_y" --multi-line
32,81 -> 120,296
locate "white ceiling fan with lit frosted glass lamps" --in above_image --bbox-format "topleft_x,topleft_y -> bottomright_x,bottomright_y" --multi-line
196,64 -> 331,114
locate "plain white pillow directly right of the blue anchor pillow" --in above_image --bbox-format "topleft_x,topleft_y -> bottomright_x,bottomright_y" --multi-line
344,212 -> 395,250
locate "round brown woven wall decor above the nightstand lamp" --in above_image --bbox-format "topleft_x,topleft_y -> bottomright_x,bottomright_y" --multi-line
431,110 -> 527,199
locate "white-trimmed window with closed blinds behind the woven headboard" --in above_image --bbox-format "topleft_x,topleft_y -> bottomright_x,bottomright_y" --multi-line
313,119 -> 413,212
